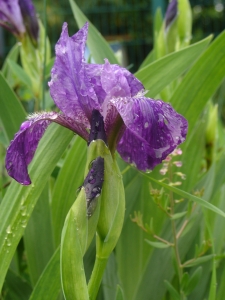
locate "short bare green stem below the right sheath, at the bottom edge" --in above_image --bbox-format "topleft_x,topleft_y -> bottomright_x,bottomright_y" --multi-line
88,256 -> 108,300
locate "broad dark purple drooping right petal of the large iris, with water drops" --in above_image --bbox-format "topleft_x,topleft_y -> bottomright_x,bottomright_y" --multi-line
112,97 -> 188,171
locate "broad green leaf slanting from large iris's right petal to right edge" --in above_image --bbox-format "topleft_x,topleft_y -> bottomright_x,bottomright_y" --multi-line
170,31 -> 225,132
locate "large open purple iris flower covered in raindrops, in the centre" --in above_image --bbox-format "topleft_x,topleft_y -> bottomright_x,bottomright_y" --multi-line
6,23 -> 188,185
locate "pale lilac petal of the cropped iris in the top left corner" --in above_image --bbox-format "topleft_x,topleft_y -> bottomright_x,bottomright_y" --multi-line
0,0 -> 25,38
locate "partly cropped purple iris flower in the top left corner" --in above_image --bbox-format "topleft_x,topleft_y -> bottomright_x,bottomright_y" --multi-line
0,0 -> 39,44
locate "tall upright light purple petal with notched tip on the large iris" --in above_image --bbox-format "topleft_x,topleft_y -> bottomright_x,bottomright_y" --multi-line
49,23 -> 100,125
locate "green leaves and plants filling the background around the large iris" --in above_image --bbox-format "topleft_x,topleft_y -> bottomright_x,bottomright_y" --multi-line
0,0 -> 225,300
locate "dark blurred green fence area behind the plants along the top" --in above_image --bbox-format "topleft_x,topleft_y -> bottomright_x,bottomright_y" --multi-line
0,0 -> 225,72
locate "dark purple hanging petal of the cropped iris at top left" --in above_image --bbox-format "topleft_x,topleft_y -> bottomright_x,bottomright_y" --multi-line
19,0 -> 39,46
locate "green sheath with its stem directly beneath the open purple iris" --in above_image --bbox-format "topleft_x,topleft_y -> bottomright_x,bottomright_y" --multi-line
88,140 -> 125,300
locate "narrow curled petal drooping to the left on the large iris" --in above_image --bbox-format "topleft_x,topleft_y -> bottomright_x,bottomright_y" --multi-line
6,112 -> 88,185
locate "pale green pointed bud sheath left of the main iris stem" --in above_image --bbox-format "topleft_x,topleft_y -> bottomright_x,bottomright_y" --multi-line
60,189 -> 89,300
